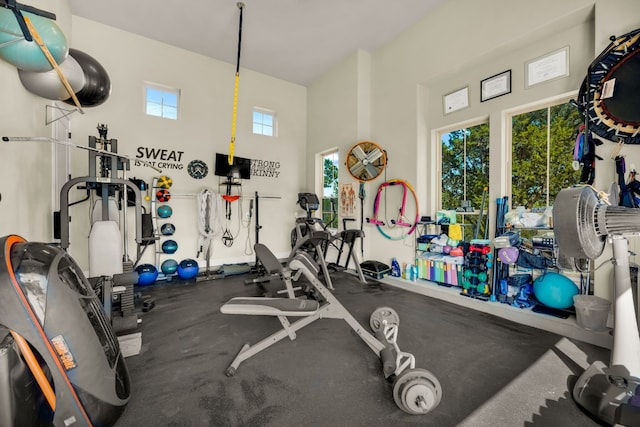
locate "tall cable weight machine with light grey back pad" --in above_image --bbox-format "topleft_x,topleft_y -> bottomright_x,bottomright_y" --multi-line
55,124 -> 150,331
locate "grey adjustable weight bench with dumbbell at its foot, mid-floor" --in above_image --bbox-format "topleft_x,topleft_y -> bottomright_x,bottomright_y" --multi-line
220,242 -> 442,415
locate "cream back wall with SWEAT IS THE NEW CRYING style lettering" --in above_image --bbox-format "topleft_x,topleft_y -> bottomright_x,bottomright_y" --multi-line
65,16 -> 307,265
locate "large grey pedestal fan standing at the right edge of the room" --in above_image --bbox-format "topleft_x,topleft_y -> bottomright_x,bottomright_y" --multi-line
553,186 -> 640,426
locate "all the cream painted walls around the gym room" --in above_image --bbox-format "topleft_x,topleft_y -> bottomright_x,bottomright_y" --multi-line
5,0 -> 639,294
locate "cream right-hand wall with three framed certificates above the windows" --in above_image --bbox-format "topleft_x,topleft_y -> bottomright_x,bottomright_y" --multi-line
372,0 -> 592,268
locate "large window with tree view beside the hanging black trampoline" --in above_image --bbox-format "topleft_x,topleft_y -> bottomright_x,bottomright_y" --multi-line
511,99 -> 582,209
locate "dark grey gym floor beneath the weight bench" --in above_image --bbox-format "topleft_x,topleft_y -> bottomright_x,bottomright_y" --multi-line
117,273 -> 609,427
